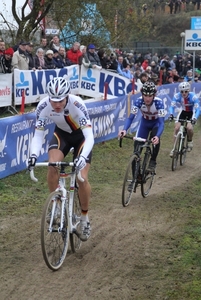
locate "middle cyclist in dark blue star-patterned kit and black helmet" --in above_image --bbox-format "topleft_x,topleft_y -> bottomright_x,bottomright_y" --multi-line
118,81 -> 165,171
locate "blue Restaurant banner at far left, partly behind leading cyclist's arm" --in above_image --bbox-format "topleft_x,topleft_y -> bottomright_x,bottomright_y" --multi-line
0,113 -> 54,178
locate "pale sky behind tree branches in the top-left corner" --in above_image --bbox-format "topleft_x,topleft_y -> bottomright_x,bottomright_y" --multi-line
0,0 -> 29,25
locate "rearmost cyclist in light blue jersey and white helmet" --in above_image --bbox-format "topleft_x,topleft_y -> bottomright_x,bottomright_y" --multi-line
169,82 -> 200,157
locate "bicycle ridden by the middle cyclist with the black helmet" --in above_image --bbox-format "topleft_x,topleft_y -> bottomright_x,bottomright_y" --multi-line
119,135 -> 156,207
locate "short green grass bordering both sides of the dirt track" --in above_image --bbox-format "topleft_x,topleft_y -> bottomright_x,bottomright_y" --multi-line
0,120 -> 201,300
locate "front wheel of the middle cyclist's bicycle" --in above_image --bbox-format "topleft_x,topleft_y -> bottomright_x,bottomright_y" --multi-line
122,155 -> 139,207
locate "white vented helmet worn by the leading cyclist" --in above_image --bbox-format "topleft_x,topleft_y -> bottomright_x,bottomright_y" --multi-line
47,77 -> 70,102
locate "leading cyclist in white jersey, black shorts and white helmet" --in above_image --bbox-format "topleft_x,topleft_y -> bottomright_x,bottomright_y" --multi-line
28,77 -> 94,241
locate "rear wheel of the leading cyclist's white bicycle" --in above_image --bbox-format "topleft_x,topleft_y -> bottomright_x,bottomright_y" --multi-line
70,188 -> 82,253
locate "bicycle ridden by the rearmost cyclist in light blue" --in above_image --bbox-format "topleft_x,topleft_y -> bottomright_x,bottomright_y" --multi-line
172,119 -> 191,171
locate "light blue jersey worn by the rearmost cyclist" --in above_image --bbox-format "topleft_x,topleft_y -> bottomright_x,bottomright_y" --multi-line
169,92 -> 200,119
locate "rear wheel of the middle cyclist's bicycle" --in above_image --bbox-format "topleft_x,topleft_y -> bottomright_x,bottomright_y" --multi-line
141,153 -> 155,198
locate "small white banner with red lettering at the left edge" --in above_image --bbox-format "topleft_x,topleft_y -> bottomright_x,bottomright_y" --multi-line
0,74 -> 12,107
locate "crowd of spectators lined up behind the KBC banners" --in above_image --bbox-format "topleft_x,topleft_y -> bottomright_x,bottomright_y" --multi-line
0,36 -> 201,88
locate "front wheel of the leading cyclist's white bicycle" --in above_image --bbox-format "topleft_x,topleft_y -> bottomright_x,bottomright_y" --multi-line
41,191 -> 69,271
